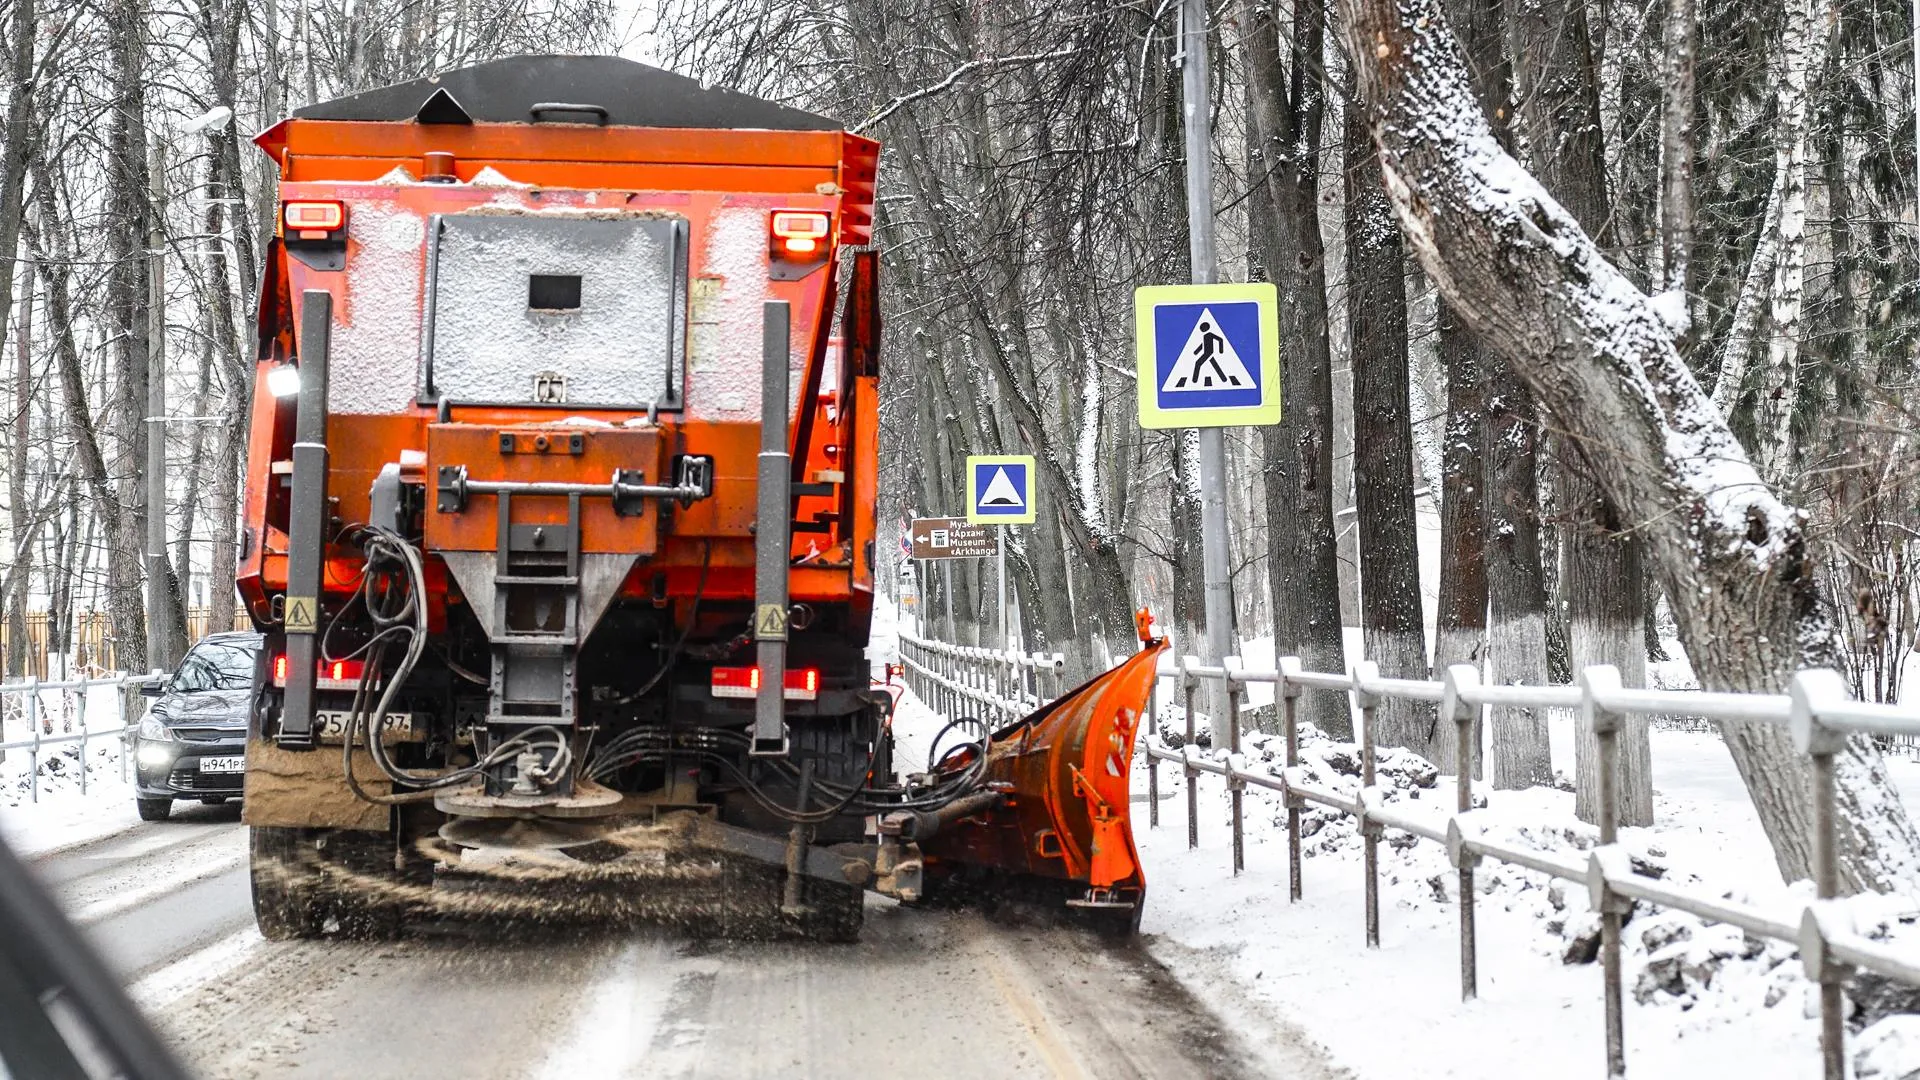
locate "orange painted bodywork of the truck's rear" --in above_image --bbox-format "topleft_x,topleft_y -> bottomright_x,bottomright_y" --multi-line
238,119 -> 879,626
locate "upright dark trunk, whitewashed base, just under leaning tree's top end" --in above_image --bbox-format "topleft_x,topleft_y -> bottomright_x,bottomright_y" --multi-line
1346,92 -> 1438,757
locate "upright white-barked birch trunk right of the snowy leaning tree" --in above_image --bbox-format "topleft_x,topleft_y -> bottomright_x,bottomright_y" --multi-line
1755,0 -> 1832,484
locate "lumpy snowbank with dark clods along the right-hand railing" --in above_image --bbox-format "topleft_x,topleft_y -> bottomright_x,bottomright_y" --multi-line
1135,726 -> 1920,1078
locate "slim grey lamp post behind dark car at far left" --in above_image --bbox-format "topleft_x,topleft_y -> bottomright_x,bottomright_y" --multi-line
146,133 -> 175,669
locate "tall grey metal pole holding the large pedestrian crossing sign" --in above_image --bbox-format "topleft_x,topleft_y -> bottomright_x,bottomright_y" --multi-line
1181,0 -> 1236,687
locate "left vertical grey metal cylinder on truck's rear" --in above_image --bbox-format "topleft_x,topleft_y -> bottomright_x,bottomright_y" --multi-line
280,288 -> 334,749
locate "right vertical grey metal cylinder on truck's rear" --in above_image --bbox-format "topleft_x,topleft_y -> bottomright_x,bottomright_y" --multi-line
753,300 -> 793,755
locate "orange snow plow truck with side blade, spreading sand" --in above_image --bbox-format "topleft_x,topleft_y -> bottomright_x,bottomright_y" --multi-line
238,58 -> 1158,940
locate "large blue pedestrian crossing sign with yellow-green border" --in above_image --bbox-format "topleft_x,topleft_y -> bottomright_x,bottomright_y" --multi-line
1133,282 -> 1281,429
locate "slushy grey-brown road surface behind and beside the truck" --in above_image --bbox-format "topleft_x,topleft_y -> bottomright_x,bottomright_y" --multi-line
22,803 -> 1336,1080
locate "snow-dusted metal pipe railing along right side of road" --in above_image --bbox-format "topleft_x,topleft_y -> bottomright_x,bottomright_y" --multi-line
900,622 -> 1920,1080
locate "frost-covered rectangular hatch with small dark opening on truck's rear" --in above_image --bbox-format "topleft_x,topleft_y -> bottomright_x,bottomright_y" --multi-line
422,213 -> 687,407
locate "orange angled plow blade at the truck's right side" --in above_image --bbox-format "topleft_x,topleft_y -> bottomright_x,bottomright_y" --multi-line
924,640 -> 1165,930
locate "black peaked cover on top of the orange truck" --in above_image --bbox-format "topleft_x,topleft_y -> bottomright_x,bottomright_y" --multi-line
294,56 -> 843,131
